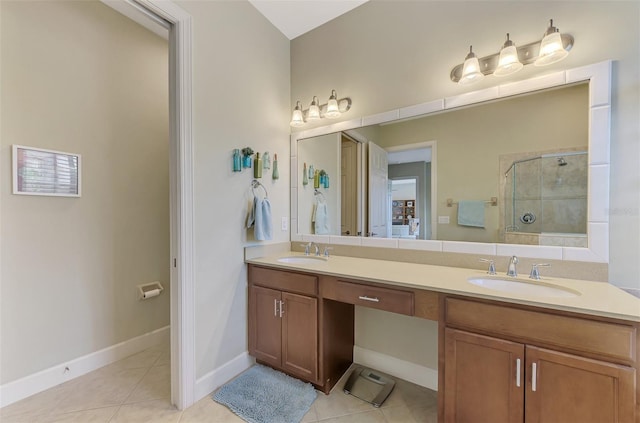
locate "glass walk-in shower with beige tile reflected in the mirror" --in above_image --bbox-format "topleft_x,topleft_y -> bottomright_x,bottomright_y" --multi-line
504,151 -> 589,247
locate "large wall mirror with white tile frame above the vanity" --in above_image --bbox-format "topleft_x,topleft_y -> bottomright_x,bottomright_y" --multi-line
291,62 -> 611,262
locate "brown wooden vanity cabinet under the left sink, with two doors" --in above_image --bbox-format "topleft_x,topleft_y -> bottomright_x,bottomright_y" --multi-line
248,265 -> 354,393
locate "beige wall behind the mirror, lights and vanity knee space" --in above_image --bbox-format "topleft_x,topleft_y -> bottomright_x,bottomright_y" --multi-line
291,0 -> 640,378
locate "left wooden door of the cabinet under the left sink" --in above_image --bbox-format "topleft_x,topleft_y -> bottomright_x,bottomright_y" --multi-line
249,286 -> 282,367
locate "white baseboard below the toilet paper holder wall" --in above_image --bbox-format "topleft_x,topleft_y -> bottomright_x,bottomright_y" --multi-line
0,326 -> 170,407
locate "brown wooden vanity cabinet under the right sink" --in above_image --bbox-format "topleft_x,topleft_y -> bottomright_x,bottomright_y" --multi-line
441,298 -> 637,423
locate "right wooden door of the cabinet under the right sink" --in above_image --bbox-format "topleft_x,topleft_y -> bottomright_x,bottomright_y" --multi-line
525,346 -> 635,423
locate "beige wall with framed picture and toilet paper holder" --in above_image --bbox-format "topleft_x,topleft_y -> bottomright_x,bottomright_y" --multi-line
0,1 -> 170,384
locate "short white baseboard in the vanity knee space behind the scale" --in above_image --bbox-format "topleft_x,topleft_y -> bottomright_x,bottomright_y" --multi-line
353,345 -> 438,391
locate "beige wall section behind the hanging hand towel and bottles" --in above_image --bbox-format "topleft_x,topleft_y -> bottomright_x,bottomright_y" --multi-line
170,1 -> 291,379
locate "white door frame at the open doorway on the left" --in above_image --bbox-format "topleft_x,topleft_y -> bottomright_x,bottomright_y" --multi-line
102,0 -> 196,410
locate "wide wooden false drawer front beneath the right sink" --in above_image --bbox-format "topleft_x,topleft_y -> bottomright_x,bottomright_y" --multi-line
445,298 -> 636,362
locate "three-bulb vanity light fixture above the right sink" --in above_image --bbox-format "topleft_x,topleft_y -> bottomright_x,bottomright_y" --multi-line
450,19 -> 574,84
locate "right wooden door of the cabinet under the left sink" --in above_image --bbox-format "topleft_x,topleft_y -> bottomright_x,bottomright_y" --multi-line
282,292 -> 318,382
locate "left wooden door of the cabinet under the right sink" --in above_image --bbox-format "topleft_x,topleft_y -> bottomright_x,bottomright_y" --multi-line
444,328 -> 524,423
